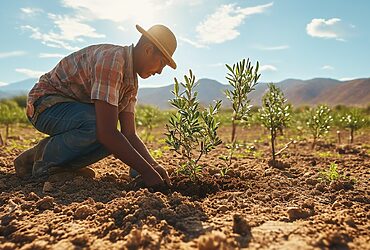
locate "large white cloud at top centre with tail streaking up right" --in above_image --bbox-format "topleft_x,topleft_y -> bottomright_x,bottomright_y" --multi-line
196,3 -> 273,44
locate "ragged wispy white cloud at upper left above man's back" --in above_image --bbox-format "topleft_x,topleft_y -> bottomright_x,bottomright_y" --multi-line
21,14 -> 105,50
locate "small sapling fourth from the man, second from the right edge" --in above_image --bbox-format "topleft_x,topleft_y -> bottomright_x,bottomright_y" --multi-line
307,105 -> 333,149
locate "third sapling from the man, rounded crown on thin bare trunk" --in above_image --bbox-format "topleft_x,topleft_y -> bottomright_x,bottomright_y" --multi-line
260,83 -> 291,162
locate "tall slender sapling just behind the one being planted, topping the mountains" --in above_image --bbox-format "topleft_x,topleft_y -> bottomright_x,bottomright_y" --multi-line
225,58 -> 261,142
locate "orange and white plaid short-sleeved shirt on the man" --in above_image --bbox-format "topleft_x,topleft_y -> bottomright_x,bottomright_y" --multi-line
27,44 -> 138,120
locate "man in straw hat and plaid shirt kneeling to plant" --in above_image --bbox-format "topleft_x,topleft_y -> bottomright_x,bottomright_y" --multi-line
14,25 -> 177,187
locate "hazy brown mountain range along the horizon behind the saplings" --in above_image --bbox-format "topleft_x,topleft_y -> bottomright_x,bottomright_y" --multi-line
0,78 -> 370,109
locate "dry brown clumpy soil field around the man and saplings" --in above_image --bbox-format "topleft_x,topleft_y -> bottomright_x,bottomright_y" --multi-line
0,120 -> 370,250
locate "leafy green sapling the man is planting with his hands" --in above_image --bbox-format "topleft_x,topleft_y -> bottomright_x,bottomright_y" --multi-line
166,70 -> 221,180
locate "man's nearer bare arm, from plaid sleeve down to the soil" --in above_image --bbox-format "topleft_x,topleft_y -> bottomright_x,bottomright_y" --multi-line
95,100 -> 163,186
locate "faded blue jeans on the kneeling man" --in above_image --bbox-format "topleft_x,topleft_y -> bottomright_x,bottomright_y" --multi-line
29,102 -> 110,177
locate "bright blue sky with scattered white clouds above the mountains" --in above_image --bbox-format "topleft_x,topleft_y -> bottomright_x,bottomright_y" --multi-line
0,0 -> 370,87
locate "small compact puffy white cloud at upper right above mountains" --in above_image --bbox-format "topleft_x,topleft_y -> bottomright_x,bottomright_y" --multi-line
306,18 -> 354,41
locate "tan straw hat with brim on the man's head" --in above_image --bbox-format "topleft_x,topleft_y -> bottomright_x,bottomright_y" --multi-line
136,24 -> 177,69
